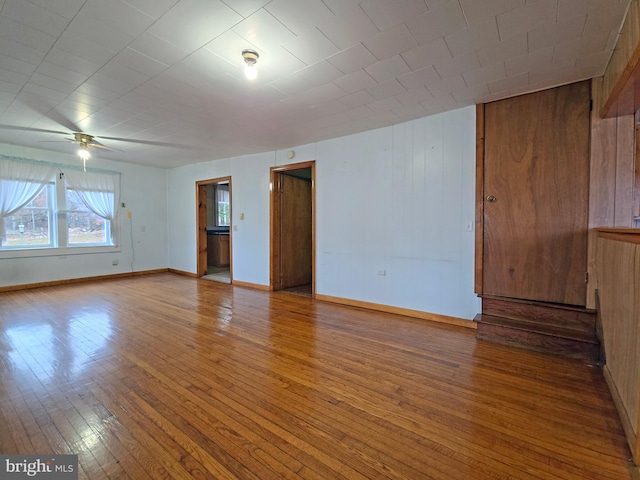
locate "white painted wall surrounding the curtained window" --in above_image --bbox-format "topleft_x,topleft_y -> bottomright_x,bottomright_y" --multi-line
0,144 -> 168,286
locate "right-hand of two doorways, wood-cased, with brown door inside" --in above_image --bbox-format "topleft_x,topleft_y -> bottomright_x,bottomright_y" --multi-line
270,161 -> 315,296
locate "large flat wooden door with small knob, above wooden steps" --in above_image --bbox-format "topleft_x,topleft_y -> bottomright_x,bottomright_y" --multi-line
482,82 -> 590,306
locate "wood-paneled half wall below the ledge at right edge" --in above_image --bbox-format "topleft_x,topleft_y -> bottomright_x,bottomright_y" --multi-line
596,229 -> 640,464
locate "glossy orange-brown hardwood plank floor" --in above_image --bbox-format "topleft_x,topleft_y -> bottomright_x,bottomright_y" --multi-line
0,273 -> 631,480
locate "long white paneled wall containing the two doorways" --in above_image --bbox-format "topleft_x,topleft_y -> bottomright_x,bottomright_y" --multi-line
168,107 -> 480,319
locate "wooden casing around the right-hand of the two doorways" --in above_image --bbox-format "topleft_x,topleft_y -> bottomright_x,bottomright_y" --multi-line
269,160 -> 316,297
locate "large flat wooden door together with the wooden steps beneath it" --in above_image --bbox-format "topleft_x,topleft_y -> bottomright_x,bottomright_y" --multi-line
475,81 -> 597,360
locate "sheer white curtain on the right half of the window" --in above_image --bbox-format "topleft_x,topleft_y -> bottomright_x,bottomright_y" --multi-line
64,169 -> 120,244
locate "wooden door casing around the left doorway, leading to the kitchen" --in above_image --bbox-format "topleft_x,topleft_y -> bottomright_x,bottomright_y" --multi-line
196,176 -> 233,283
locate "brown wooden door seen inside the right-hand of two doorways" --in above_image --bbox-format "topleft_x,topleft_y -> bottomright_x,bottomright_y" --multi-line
280,173 -> 312,288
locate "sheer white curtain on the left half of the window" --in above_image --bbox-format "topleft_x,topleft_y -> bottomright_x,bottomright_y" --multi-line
0,155 -> 56,245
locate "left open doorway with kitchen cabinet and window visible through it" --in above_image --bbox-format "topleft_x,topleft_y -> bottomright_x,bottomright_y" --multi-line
196,177 -> 233,283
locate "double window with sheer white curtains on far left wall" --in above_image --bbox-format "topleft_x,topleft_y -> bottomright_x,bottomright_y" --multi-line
0,156 -> 120,253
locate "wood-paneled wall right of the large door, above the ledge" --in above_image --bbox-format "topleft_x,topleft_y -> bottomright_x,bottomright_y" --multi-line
587,77 -> 637,308
